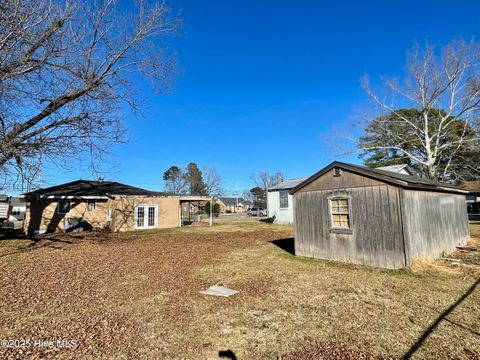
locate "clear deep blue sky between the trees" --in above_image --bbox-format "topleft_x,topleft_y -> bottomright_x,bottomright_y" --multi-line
39,0 -> 480,197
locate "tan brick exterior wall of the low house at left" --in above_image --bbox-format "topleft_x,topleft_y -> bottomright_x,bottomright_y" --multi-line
24,196 -> 180,234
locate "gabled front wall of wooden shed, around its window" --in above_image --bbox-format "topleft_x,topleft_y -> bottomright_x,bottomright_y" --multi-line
294,170 -> 406,269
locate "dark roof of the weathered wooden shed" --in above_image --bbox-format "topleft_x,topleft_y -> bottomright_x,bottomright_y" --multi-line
290,161 -> 467,194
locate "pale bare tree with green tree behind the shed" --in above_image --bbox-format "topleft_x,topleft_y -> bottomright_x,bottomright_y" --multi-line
359,40 -> 480,181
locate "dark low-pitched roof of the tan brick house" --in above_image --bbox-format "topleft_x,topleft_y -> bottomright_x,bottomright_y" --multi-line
24,180 -> 171,199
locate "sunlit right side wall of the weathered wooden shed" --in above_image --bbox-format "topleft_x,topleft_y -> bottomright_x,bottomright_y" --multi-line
403,190 -> 469,259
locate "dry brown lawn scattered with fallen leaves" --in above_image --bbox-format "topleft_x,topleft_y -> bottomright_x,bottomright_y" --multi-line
0,221 -> 480,359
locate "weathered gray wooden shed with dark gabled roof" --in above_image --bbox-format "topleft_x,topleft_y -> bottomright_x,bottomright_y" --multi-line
290,162 -> 469,269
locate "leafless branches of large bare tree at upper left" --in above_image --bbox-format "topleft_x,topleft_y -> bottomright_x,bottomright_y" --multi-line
0,0 -> 180,184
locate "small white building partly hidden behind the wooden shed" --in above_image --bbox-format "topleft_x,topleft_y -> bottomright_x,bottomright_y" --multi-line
267,178 -> 306,224
